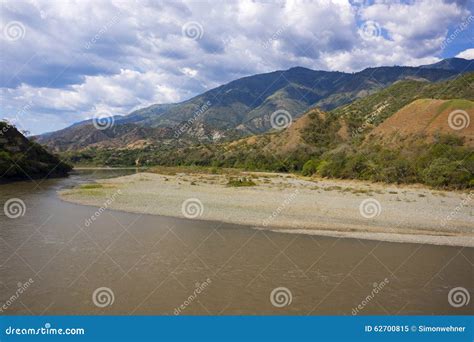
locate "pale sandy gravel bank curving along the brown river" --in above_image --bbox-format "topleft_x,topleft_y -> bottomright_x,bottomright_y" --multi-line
60,173 -> 474,247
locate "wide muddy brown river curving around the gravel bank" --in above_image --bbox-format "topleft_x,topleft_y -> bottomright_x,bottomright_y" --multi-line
0,170 -> 474,315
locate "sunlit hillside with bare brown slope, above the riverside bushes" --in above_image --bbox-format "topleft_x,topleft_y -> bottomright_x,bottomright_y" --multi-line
179,73 -> 474,171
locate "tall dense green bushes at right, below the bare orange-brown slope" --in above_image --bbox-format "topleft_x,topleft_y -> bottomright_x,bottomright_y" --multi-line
306,136 -> 474,189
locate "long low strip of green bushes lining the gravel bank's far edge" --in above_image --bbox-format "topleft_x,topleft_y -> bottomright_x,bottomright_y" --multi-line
57,131 -> 474,189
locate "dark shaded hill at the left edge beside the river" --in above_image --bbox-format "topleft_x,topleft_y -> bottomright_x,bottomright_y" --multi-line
0,121 -> 71,182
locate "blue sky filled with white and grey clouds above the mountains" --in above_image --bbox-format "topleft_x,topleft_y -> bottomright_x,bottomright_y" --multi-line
0,0 -> 474,134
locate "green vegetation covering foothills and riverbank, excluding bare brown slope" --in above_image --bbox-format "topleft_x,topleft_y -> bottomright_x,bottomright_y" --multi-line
57,73 -> 474,189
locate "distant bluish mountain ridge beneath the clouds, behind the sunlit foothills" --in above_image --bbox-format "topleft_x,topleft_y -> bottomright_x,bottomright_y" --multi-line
114,60 -> 471,133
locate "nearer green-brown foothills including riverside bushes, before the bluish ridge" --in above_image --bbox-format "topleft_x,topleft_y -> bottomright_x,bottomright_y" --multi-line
55,69 -> 474,189
